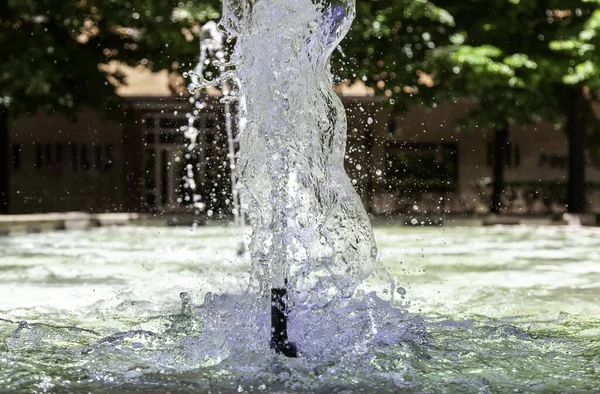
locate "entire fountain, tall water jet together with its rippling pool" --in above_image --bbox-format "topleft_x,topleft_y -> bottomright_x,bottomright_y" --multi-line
0,0 -> 600,393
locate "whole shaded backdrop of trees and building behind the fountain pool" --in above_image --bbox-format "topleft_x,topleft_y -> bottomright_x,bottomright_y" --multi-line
0,0 -> 600,222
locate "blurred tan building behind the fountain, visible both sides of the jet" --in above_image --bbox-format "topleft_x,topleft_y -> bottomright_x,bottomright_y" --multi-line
3,74 -> 600,215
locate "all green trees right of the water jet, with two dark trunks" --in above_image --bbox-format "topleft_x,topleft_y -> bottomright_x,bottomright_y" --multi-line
345,0 -> 600,212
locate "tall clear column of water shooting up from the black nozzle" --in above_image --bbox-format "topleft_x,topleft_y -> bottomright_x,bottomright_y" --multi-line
221,0 -> 377,302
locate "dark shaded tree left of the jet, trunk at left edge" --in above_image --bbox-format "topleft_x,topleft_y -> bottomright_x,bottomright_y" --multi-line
0,0 -> 220,213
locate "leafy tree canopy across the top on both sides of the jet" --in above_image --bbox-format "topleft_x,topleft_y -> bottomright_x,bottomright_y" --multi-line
0,0 -> 600,215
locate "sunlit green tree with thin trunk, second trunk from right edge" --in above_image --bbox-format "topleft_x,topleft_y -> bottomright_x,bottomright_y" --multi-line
424,0 -> 557,214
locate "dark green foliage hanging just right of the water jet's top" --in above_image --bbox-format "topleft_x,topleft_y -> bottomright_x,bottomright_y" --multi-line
334,0 -> 454,108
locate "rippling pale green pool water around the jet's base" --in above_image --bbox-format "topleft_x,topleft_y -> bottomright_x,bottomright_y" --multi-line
0,226 -> 600,393
